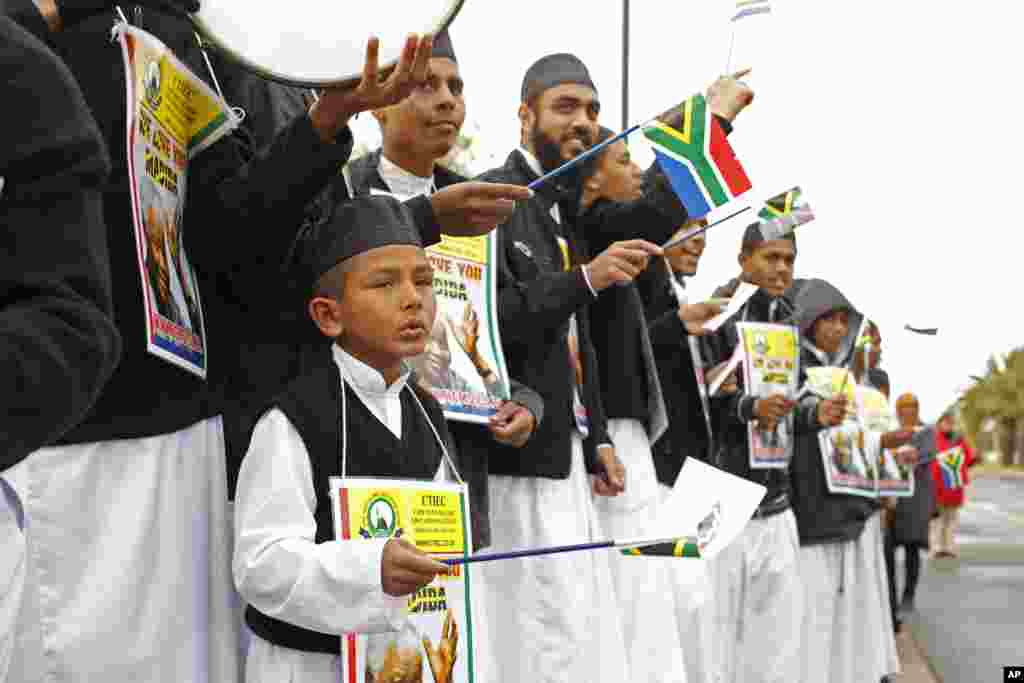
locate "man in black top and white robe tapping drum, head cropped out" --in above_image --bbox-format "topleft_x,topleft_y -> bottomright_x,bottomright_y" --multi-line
7,0 -> 526,683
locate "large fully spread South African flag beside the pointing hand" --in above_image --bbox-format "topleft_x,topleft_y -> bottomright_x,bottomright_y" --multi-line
643,94 -> 752,220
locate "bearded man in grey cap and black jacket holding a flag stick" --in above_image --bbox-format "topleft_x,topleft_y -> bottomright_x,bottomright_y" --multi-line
482,53 -> 750,682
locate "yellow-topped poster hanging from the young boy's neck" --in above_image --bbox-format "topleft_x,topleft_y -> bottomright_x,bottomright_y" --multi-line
331,477 -> 475,683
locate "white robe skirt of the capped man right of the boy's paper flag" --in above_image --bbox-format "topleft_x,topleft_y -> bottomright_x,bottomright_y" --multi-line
711,510 -> 804,683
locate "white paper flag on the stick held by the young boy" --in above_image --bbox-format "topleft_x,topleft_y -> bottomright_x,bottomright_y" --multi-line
633,458 -> 767,559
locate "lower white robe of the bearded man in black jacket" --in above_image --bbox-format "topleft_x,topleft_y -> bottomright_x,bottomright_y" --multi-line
479,434 -> 636,683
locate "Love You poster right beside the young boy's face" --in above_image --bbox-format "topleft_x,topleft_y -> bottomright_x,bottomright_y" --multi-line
412,234 -> 510,423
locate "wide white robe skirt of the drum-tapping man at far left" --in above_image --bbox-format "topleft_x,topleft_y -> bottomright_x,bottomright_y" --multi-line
0,418 -> 241,683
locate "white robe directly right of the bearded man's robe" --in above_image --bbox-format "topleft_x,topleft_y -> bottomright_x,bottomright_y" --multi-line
594,419 -> 687,683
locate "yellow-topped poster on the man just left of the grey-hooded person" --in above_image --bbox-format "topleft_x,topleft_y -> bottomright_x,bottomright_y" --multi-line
736,323 -> 800,469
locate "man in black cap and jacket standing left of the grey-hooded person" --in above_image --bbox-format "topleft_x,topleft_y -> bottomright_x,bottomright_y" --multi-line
707,222 -> 842,683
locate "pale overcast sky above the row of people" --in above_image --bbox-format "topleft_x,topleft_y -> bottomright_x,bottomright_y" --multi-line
350,0 -> 1024,420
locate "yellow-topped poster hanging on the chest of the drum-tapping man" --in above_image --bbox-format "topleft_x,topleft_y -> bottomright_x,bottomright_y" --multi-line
115,24 -> 239,378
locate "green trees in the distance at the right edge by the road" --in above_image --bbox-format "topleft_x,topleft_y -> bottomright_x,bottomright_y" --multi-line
958,347 -> 1024,465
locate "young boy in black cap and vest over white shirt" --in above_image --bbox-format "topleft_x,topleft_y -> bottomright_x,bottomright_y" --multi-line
233,197 -> 451,683
